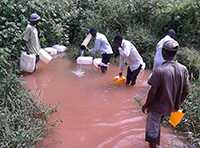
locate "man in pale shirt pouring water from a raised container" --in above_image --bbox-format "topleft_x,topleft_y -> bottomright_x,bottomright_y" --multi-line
89,28 -> 113,73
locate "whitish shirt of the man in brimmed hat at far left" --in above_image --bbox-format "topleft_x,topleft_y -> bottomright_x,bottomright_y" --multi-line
23,24 -> 40,54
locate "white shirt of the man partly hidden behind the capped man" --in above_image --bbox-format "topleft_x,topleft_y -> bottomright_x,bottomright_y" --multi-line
153,35 -> 174,69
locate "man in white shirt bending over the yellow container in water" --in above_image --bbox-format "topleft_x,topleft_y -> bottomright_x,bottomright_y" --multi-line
114,35 -> 144,86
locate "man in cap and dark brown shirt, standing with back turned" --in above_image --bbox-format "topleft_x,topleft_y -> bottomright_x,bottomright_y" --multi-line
142,40 -> 189,148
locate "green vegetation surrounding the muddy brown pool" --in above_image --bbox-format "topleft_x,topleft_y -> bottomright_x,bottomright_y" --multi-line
0,0 -> 200,147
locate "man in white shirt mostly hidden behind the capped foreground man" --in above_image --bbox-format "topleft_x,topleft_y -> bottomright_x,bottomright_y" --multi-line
153,29 -> 176,69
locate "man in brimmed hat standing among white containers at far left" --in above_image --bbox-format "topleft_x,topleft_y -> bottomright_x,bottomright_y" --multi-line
23,13 -> 41,71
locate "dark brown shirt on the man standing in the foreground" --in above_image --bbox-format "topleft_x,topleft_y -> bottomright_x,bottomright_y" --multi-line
149,61 -> 188,114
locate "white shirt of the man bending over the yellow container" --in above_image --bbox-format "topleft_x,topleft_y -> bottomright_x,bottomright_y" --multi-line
119,40 -> 144,71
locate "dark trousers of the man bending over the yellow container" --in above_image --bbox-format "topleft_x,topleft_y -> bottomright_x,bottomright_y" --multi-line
126,64 -> 142,86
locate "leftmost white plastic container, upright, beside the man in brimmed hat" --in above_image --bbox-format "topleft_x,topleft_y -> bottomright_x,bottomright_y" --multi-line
20,52 -> 36,73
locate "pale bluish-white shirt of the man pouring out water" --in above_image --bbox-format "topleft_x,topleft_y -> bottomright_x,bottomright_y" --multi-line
92,32 -> 113,54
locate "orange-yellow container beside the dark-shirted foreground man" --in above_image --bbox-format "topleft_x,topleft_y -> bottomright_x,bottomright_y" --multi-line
169,110 -> 185,127
